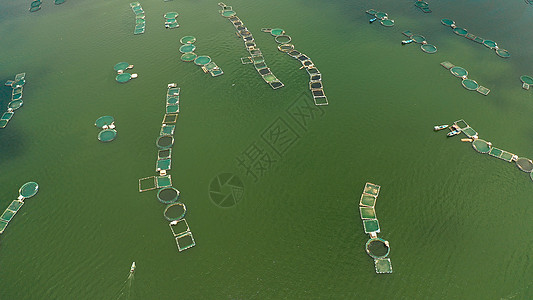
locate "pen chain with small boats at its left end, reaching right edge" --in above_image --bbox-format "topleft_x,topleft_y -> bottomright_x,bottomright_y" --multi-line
436,120 -> 533,180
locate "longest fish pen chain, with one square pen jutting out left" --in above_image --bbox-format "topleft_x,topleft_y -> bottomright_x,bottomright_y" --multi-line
139,83 -> 196,252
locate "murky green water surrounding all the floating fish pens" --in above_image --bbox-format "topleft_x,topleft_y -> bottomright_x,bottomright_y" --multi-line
0,0 -> 533,299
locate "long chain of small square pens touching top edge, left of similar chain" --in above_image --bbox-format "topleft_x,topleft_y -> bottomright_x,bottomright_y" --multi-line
218,2 -> 283,89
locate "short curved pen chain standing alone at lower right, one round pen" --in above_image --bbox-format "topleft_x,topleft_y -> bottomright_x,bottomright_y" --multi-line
359,182 -> 392,273
